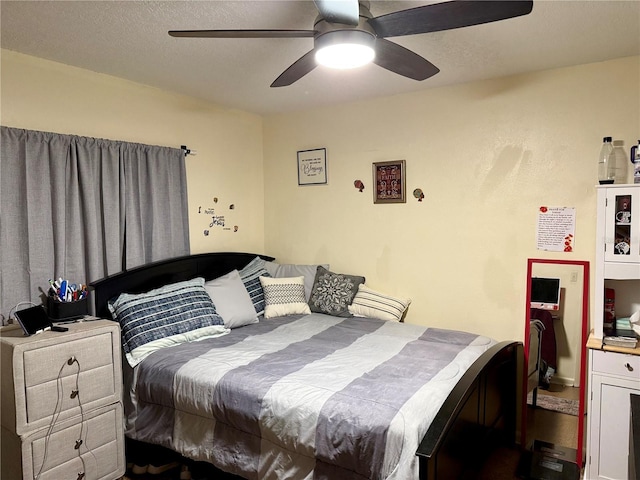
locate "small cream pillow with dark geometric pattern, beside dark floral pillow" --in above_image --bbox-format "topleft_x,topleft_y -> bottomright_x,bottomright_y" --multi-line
260,276 -> 311,318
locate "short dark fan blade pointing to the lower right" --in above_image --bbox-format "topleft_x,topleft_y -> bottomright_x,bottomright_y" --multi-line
373,38 -> 440,80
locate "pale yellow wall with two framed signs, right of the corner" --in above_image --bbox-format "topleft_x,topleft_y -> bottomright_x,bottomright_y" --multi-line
264,57 -> 640,339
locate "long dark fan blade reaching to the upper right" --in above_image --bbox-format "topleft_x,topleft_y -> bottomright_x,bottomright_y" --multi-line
369,0 -> 533,37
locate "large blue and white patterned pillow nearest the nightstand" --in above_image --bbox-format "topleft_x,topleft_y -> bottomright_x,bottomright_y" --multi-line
109,278 -> 229,367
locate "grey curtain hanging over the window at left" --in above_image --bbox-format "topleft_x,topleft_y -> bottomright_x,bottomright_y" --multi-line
0,127 -> 189,318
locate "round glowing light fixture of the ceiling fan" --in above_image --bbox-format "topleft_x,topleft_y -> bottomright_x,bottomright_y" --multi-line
315,30 -> 376,69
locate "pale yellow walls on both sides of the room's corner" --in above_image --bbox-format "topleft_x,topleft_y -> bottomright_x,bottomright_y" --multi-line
5,50 -> 640,350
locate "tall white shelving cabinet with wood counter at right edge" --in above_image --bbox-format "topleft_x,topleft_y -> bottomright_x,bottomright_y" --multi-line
585,185 -> 640,480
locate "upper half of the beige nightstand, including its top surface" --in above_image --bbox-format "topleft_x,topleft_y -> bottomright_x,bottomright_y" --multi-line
1,320 -> 122,435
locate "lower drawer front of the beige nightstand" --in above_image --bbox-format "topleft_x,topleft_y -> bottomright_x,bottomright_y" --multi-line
22,403 -> 125,480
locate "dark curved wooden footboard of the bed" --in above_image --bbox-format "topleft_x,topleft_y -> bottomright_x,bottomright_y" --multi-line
416,342 -> 523,480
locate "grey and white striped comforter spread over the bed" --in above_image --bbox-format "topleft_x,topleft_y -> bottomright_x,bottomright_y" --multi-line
127,314 -> 495,480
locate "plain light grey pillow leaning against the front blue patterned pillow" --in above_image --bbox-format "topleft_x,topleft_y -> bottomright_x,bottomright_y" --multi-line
204,270 -> 258,328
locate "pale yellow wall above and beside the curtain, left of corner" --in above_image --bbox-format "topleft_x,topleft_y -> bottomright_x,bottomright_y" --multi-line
0,50 -> 264,253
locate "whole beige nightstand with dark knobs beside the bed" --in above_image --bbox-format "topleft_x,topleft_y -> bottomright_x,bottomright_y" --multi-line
0,320 -> 125,480
